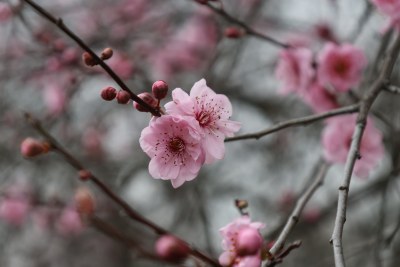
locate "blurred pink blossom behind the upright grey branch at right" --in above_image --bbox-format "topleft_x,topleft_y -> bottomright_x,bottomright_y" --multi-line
322,115 -> 384,177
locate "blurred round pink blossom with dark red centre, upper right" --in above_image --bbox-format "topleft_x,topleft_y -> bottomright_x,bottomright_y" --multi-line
318,43 -> 367,92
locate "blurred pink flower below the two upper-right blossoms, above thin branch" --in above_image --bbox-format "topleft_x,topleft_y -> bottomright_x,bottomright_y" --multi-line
301,83 -> 339,113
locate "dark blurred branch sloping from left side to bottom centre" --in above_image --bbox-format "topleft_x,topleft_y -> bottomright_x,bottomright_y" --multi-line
25,113 -> 220,267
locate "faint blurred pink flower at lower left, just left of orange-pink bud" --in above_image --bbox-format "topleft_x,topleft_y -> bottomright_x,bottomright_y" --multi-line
56,207 -> 84,235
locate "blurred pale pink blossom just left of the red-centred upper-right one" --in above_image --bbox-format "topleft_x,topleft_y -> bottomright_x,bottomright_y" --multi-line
275,48 -> 315,95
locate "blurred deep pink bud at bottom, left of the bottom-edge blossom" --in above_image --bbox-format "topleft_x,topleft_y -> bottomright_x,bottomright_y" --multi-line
155,235 -> 189,262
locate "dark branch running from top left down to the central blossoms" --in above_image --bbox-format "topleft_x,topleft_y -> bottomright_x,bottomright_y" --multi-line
24,0 -> 161,117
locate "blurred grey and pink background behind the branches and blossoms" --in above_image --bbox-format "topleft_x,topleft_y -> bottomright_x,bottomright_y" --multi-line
0,0 -> 400,267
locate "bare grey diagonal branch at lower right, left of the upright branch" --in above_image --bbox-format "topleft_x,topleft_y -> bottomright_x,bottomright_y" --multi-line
266,162 -> 330,266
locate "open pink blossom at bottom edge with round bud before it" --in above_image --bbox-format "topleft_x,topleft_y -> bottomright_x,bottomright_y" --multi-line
219,216 -> 264,267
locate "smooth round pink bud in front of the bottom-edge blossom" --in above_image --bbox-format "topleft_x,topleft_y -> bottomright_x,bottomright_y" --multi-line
237,227 -> 263,256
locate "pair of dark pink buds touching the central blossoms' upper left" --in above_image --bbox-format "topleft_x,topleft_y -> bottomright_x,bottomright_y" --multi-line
133,80 -> 168,112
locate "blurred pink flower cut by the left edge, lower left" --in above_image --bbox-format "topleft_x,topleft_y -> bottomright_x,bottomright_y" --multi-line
0,197 -> 31,226
